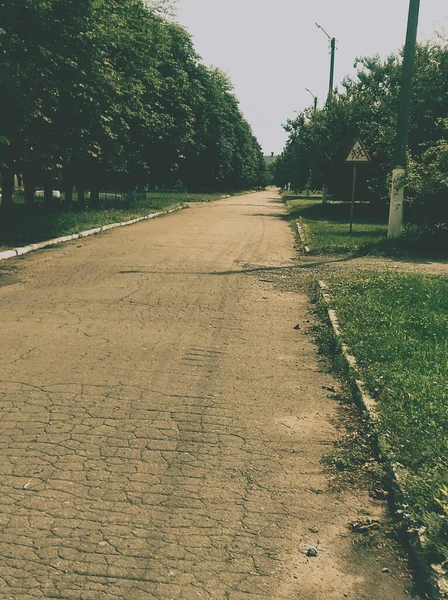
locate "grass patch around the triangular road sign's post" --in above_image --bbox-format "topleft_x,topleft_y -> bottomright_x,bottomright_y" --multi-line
284,196 -> 448,257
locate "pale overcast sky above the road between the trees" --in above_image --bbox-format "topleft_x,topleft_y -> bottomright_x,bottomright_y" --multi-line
177,0 -> 448,154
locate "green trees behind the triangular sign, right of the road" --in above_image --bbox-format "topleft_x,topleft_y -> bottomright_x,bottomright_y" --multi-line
275,36 -> 448,225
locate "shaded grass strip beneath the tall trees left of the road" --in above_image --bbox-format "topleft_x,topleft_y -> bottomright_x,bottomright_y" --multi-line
0,192 -> 228,250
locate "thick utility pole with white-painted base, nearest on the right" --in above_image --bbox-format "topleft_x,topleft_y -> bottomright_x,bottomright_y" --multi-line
387,0 -> 420,239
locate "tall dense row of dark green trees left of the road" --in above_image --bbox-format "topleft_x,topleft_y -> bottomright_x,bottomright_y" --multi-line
0,0 -> 264,207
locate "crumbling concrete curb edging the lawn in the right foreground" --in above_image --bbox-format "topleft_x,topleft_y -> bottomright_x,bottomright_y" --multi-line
318,281 -> 448,600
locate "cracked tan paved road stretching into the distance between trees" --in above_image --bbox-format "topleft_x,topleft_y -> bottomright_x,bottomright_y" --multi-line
0,192 -> 409,600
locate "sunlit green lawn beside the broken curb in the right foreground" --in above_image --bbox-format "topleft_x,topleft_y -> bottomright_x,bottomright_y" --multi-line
327,271 -> 448,560
